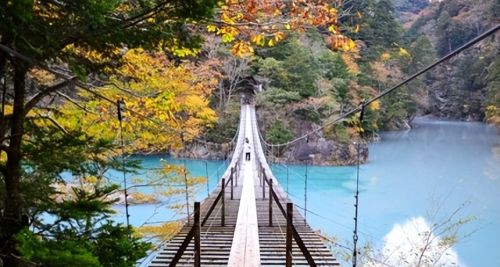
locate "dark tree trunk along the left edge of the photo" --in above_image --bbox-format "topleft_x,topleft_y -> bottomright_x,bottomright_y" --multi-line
0,64 -> 27,266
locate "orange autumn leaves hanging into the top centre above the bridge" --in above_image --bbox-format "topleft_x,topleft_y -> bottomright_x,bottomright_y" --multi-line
207,0 -> 355,57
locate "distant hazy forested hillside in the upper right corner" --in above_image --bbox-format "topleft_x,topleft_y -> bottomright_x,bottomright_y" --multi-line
404,0 -> 500,124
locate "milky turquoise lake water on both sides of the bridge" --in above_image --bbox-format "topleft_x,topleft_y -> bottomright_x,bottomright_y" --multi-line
112,119 -> 500,267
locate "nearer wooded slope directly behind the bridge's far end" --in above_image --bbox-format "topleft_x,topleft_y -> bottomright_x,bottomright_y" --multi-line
199,0 -> 416,165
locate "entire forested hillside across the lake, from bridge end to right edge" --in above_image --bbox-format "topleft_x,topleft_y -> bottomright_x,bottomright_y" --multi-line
200,0 -> 500,164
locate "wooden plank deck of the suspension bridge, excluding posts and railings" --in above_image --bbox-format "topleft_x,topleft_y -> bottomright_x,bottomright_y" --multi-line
149,106 -> 339,267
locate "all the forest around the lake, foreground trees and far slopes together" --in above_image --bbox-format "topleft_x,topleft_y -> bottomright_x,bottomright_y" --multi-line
0,0 -> 500,266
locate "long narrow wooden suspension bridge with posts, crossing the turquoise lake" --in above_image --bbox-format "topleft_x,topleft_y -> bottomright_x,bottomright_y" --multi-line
149,104 -> 339,267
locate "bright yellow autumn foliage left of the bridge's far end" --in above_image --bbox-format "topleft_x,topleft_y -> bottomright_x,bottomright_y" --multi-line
58,49 -> 217,152
